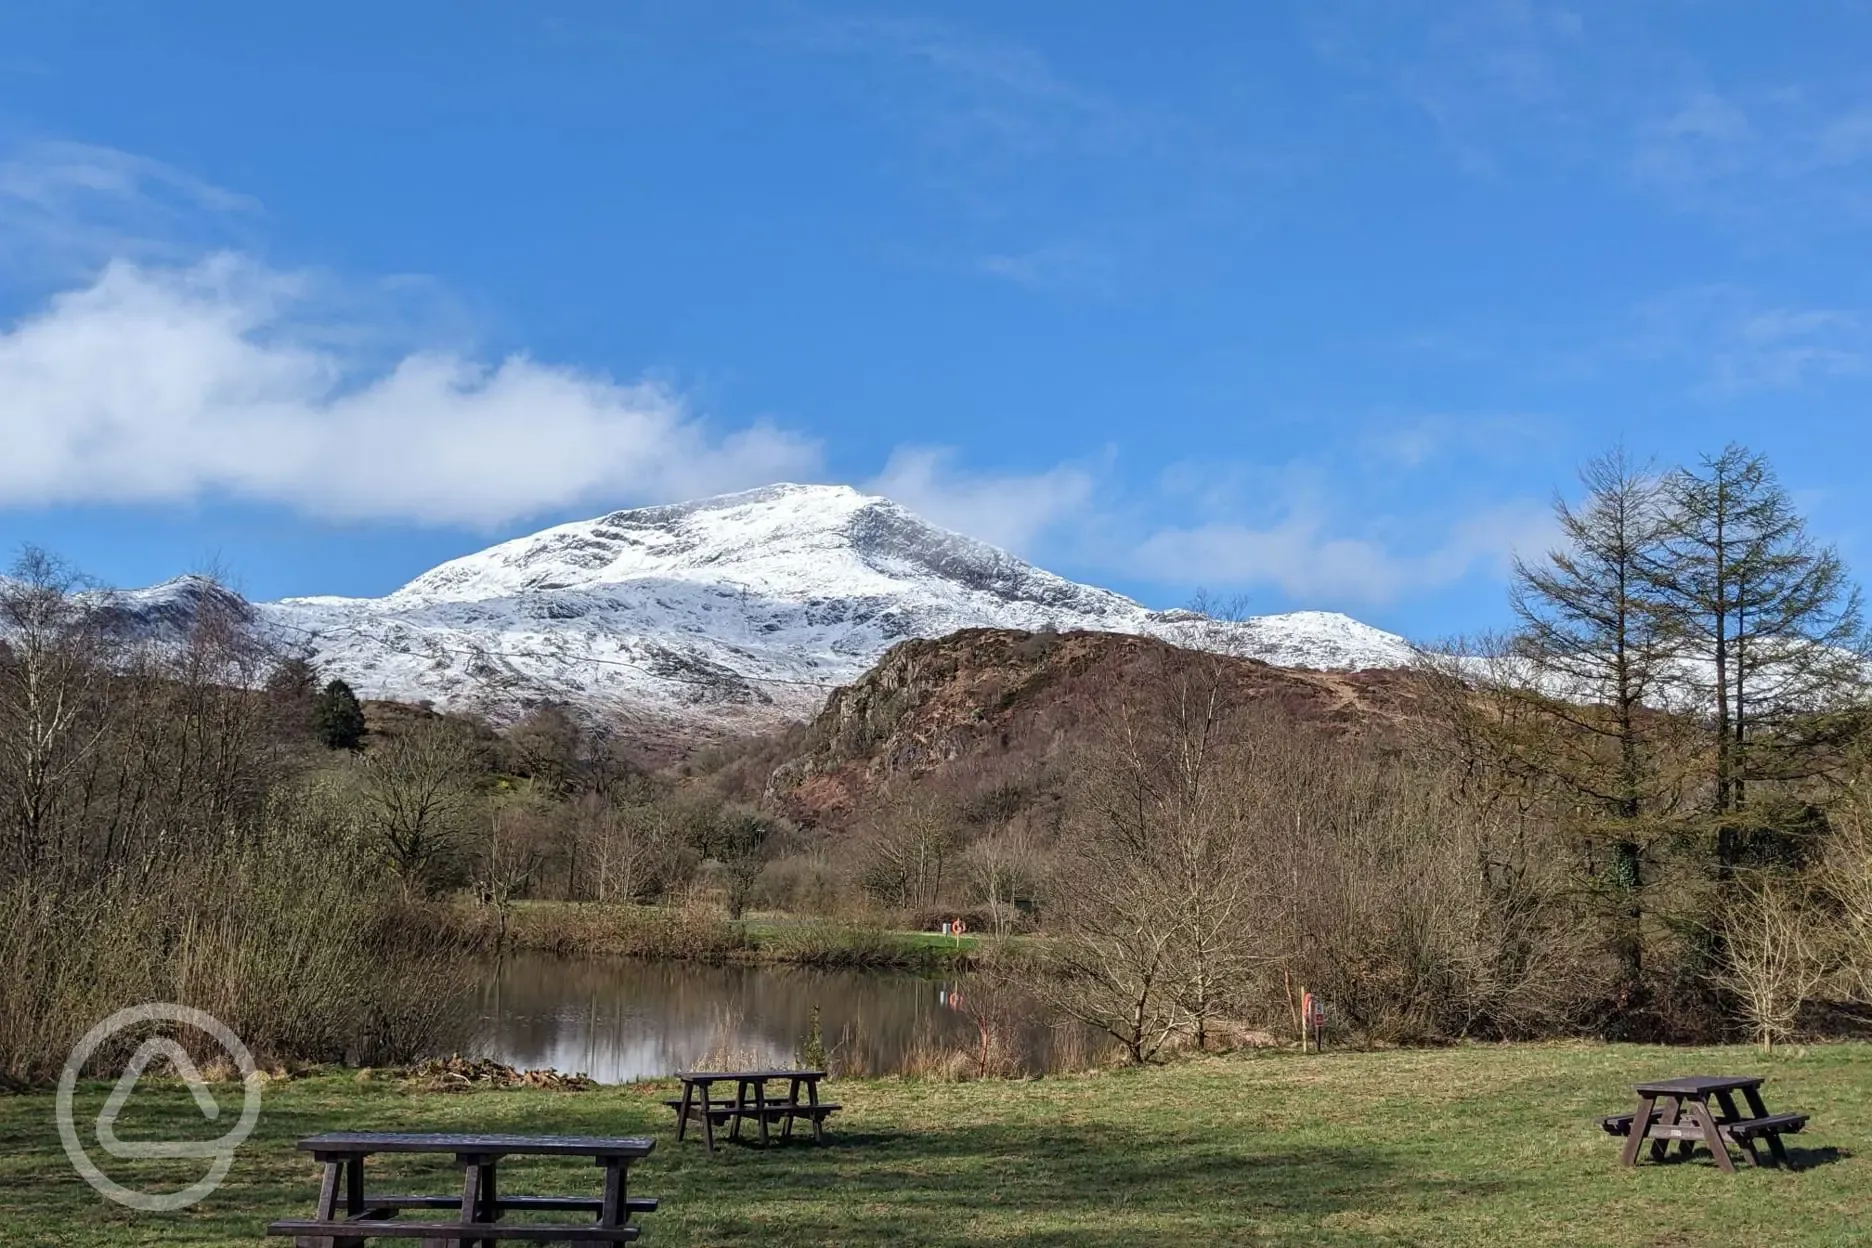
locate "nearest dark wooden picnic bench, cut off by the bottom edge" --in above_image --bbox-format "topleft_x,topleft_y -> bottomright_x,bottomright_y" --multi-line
266,1132 -> 657,1248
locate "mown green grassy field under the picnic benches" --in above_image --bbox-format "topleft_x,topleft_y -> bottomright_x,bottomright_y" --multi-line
0,1046 -> 1872,1248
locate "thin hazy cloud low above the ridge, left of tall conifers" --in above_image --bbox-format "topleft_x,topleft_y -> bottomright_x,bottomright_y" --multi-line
1133,501 -> 1552,604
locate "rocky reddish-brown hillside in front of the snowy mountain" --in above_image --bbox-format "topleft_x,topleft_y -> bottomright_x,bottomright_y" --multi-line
769,629 -> 1421,825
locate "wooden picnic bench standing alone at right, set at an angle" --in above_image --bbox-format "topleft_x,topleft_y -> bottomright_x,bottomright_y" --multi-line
1599,1074 -> 1806,1173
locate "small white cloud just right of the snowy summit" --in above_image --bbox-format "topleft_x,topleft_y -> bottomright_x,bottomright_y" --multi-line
869,447 -> 1093,552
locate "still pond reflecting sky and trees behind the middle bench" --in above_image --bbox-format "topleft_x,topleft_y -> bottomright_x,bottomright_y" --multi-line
470,954 -> 1099,1083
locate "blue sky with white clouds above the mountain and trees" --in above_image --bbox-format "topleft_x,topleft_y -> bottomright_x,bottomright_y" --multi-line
0,0 -> 1872,638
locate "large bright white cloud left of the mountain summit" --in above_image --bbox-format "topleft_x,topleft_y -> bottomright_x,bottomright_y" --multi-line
0,254 -> 818,526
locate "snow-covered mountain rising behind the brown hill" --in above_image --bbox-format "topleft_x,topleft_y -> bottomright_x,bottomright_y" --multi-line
106,485 -> 1411,730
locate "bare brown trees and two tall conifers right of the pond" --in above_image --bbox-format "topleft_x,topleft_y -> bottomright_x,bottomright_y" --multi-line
1045,445 -> 1872,1059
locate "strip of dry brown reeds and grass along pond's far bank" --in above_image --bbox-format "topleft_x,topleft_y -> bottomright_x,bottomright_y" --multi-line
468,902 -> 1022,975
